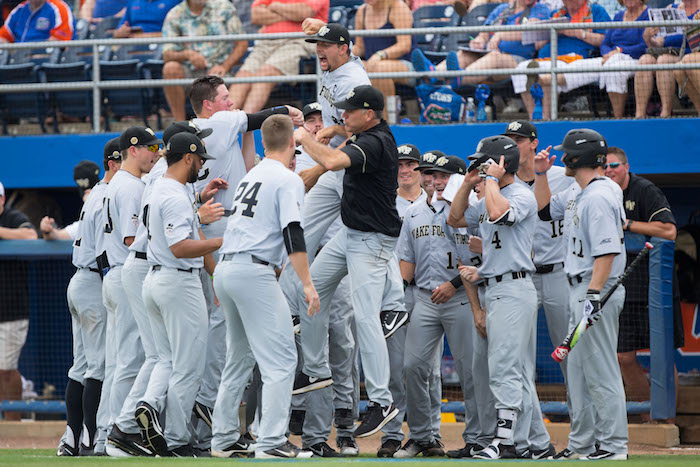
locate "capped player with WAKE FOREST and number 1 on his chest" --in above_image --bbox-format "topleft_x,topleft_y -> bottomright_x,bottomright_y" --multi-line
394,155 -> 476,458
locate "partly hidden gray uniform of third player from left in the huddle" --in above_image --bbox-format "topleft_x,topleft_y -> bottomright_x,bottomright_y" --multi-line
115,157 -> 170,434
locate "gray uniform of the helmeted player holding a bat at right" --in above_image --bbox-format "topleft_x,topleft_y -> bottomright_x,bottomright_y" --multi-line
564,178 -> 627,454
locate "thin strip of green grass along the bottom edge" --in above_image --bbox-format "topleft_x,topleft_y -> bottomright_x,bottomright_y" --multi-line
0,449 -> 698,467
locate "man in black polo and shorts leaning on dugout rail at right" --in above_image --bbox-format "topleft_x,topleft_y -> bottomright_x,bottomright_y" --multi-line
605,147 -> 684,422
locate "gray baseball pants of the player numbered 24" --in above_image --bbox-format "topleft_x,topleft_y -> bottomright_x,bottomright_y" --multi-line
211,254 -> 297,453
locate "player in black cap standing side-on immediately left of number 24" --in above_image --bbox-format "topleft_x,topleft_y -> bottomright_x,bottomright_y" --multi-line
137,132 -> 221,457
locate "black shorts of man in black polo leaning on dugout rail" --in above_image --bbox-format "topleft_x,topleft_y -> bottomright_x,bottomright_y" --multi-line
617,298 -> 685,353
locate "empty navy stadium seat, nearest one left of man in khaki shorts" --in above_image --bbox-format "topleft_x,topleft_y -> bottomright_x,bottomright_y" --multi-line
100,59 -> 152,131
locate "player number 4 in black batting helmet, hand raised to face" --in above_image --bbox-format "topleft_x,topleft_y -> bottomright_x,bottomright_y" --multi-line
460,136 -> 537,459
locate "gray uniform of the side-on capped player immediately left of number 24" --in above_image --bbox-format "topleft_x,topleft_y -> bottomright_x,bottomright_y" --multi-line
143,176 -> 208,450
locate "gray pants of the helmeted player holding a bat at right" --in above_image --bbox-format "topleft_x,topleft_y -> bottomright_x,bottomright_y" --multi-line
566,276 -> 628,454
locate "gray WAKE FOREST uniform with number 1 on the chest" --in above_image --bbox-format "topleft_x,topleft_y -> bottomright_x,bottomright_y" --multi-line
397,198 -> 478,443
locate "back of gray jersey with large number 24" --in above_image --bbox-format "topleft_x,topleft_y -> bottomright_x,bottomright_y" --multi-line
221,158 -> 304,266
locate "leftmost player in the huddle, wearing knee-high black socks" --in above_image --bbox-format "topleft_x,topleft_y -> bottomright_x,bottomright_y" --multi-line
57,138 -> 121,456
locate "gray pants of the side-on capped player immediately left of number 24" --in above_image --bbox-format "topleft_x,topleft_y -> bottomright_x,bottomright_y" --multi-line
143,267 -> 209,449
